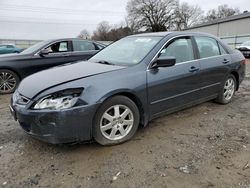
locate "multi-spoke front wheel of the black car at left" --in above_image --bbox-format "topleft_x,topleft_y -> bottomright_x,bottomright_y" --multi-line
0,69 -> 20,94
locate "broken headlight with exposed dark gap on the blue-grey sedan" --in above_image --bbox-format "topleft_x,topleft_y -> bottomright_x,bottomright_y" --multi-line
33,88 -> 83,110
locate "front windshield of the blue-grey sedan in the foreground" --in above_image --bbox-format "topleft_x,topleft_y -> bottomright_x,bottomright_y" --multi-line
90,37 -> 162,65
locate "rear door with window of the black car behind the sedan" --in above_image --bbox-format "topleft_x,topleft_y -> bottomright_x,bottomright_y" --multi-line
70,39 -> 100,62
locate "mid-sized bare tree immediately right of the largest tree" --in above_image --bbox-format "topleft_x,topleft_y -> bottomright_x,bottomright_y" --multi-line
175,2 -> 204,30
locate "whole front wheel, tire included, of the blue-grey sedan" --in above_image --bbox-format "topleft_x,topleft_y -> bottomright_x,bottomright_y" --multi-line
93,96 -> 140,145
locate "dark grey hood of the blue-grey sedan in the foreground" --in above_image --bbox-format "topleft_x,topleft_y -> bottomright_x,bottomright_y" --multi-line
18,61 -> 125,99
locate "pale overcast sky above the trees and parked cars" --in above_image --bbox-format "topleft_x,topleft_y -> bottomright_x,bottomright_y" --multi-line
0,0 -> 250,40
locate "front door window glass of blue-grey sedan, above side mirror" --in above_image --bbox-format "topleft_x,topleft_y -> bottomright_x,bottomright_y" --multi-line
159,38 -> 194,63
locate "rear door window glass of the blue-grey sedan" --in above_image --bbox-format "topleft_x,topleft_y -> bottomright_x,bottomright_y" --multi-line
195,37 -> 220,58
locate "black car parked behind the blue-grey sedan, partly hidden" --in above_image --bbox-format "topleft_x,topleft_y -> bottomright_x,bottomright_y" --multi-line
0,39 -> 106,94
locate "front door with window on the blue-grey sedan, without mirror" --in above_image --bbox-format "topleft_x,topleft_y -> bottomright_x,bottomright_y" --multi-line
147,36 -> 200,117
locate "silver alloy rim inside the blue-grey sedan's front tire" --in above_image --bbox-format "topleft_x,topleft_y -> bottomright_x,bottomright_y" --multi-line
100,105 -> 134,140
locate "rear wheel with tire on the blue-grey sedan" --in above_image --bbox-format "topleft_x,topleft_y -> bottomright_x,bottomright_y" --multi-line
215,74 -> 237,104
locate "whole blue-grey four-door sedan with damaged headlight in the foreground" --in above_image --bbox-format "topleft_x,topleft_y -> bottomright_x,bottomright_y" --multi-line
10,32 -> 246,145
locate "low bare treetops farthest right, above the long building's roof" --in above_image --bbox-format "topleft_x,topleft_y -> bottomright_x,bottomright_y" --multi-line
205,4 -> 240,21
